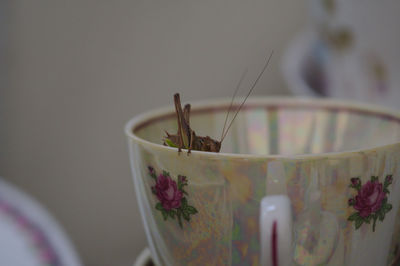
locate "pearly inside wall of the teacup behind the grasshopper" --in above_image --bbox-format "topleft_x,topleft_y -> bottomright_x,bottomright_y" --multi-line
132,99 -> 400,155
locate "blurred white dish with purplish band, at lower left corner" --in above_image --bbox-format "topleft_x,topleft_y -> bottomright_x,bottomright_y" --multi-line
0,178 -> 81,266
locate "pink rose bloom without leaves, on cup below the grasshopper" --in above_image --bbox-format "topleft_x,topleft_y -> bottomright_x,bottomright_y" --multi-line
152,174 -> 183,211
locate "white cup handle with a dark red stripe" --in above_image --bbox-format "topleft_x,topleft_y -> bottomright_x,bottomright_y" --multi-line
260,195 -> 292,266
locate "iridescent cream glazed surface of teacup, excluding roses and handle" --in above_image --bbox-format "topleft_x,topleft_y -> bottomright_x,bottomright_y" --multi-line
126,98 -> 400,265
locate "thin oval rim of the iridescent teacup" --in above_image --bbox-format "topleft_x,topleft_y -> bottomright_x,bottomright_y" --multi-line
124,96 -> 400,160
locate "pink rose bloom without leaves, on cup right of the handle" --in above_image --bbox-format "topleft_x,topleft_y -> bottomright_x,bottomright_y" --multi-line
354,181 -> 386,218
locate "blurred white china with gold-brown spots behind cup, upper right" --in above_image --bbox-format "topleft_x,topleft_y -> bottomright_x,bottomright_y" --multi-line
283,0 -> 400,108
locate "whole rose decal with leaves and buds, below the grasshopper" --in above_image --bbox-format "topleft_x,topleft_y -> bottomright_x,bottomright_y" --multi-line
148,166 -> 197,228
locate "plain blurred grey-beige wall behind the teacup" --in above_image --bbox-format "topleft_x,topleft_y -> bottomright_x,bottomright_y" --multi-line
0,0 -> 306,265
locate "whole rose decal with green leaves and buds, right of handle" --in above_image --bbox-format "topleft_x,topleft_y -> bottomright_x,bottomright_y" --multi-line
348,175 -> 393,232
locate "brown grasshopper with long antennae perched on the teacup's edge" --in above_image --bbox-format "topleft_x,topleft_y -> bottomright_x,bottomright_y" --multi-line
163,52 -> 273,154
